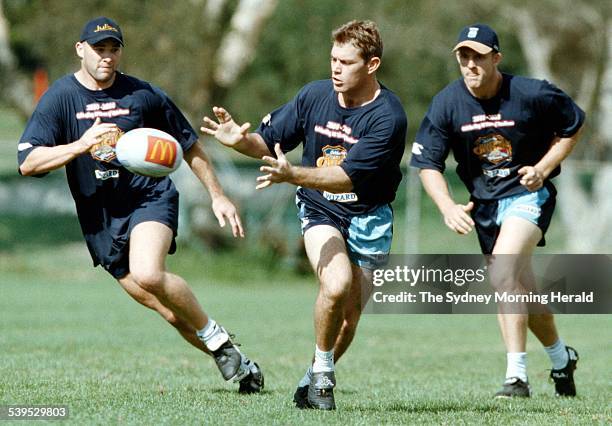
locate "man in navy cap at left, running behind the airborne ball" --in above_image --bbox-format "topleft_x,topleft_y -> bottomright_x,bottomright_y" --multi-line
17,17 -> 264,393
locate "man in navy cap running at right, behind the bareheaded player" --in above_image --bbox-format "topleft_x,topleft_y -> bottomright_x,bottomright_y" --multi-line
410,24 -> 585,397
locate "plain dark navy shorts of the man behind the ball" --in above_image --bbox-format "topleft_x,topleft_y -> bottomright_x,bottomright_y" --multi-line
85,188 -> 179,279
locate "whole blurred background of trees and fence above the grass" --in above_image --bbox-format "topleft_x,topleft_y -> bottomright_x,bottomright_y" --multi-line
0,0 -> 612,268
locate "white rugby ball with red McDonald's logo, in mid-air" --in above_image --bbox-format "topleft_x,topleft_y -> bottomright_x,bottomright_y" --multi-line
115,127 -> 183,177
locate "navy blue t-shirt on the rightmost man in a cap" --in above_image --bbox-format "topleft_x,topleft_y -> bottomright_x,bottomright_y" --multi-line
410,74 -> 585,200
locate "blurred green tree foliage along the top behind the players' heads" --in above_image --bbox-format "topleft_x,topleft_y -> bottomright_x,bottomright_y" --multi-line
4,0 -> 603,140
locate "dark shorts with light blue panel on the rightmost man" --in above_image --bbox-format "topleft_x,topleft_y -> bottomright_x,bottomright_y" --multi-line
472,182 -> 557,254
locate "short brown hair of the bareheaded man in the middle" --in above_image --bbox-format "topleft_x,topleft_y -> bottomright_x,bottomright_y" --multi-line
332,21 -> 382,62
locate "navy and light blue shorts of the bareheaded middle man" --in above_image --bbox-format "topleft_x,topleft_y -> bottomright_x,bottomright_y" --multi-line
296,197 -> 393,269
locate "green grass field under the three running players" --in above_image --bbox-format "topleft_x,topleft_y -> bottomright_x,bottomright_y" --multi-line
0,243 -> 612,424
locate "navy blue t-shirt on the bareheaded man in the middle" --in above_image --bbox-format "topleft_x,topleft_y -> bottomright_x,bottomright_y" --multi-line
257,80 -> 408,215
